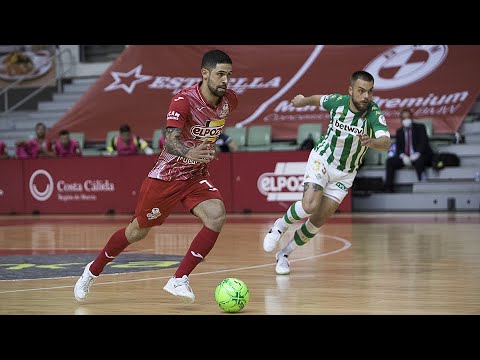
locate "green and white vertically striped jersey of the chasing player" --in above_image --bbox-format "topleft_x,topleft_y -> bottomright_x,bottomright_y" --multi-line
313,94 -> 390,173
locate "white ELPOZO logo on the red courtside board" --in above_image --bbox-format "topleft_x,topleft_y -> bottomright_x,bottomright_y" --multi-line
257,162 -> 307,202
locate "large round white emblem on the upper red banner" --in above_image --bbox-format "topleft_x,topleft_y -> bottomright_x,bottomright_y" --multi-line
364,45 -> 448,90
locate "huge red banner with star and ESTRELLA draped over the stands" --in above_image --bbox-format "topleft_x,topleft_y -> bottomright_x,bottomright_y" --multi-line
49,45 -> 480,141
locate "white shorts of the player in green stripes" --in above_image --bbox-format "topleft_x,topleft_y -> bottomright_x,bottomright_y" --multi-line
302,150 -> 357,204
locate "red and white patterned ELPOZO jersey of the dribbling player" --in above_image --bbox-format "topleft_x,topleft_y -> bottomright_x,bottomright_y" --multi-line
148,83 -> 238,181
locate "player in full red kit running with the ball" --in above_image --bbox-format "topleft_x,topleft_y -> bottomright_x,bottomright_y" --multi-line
74,50 -> 238,303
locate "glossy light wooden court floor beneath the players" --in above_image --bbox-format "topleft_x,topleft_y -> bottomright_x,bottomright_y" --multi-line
0,213 -> 480,316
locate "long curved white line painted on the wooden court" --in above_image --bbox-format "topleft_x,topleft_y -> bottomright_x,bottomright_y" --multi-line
0,235 -> 352,294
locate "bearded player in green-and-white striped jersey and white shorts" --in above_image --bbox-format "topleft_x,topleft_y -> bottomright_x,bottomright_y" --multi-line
263,71 -> 390,275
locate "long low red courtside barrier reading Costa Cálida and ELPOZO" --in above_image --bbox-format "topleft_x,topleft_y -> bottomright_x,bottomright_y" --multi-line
0,151 -> 351,214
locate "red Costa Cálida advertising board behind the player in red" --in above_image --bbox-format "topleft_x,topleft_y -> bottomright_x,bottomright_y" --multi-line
13,154 -> 232,214
